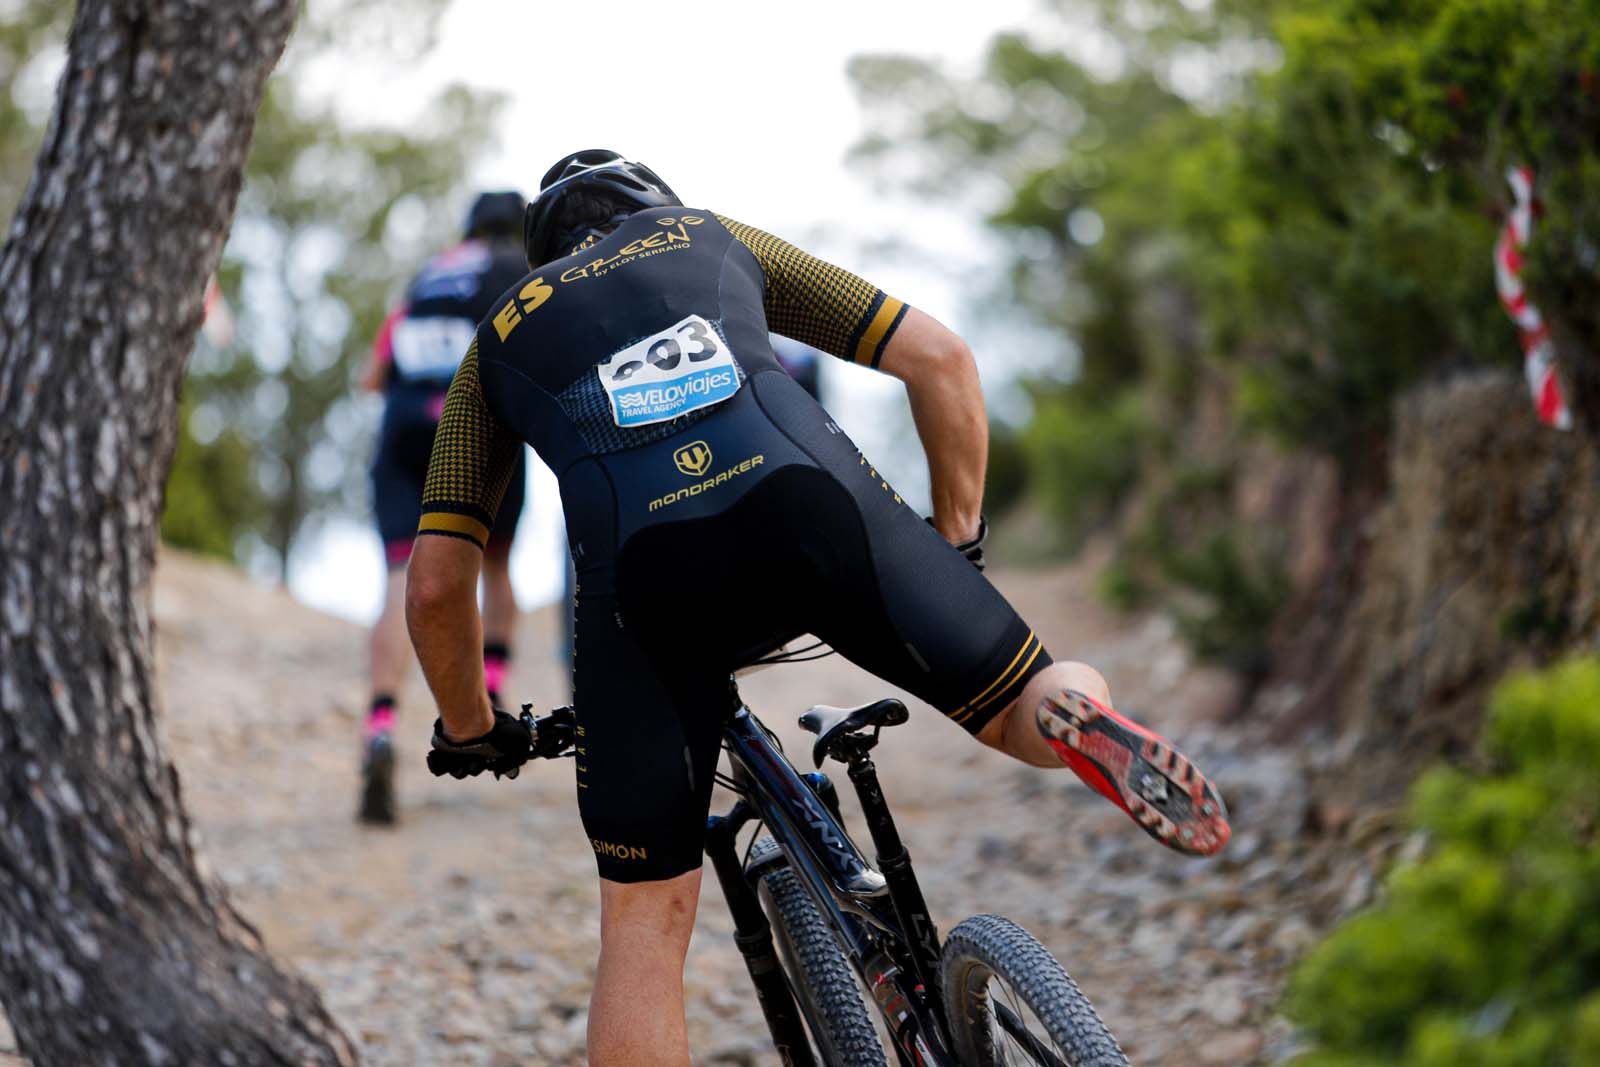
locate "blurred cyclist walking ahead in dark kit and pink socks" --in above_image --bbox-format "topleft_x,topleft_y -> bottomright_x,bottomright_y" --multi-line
360,192 -> 528,824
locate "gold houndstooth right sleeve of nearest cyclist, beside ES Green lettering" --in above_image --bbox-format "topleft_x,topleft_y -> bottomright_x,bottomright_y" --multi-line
717,214 -> 906,366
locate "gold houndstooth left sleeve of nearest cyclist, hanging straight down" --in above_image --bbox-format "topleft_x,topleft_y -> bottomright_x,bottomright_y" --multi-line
416,338 -> 522,549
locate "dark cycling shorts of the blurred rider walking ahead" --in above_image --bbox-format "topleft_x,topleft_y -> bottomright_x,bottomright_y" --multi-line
371,387 -> 528,566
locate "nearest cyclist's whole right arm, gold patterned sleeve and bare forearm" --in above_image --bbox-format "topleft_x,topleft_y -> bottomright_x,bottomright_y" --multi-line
717,216 -> 989,544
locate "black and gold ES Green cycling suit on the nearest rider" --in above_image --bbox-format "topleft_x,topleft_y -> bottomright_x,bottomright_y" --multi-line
419,208 -> 1050,881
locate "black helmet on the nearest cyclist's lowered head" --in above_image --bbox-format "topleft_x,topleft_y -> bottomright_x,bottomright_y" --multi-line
522,149 -> 683,267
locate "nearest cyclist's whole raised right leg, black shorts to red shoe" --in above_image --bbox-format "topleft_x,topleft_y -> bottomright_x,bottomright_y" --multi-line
742,374 -> 1227,856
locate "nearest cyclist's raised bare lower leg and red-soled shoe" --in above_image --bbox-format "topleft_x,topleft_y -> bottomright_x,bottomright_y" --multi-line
978,662 -> 1230,856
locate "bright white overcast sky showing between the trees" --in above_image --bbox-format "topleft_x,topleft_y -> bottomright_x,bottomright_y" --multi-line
291,0 -> 1037,621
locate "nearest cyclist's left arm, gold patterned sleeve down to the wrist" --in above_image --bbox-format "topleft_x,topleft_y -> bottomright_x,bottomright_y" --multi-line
406,341 -> 522,739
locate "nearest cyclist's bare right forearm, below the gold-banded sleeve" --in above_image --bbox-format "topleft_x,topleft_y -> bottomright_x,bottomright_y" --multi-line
878,307 -> 989,544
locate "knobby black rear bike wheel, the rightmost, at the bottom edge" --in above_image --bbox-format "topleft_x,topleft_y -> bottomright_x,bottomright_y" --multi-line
939,915 -> 1128,1067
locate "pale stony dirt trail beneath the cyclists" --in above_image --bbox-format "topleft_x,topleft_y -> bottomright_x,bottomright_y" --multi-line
0,552 -> 1371,1067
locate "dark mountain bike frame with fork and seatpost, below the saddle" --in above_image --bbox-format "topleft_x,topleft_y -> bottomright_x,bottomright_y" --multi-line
706,689 -> 955,1067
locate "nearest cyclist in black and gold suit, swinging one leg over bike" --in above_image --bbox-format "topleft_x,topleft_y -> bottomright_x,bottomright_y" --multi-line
406,150 -> 1229,1067
